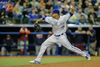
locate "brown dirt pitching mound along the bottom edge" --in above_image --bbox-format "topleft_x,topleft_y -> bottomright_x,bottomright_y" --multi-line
6,60 -> 100,67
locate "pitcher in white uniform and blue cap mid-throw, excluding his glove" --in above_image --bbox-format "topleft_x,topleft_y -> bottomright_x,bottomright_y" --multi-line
29,7 -> 91,64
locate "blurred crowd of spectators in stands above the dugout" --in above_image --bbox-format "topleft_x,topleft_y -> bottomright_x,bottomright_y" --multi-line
0,0 -> 100,25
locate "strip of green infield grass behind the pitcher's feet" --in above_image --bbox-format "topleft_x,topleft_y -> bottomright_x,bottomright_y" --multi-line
0,56 -> 100,67
